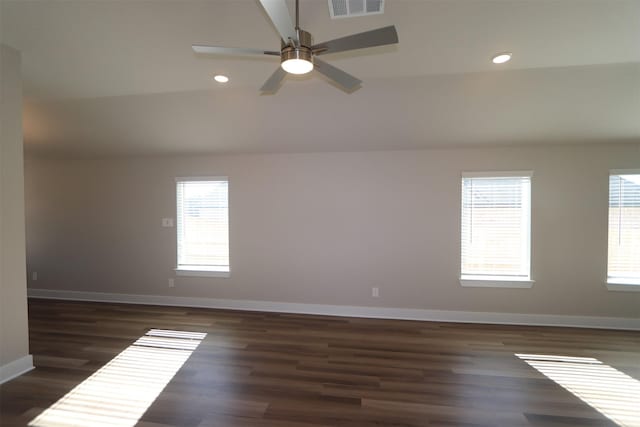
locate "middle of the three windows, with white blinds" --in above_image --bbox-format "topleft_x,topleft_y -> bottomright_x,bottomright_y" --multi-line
460,172 -> 533,288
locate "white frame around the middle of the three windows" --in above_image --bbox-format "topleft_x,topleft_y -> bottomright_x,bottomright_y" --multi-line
458,170 -> 535,289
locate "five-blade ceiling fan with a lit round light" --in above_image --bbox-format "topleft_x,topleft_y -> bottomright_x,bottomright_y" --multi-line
192,0 -> 398,93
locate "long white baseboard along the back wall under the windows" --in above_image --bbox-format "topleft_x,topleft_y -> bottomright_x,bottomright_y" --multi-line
27,289 -> 640,331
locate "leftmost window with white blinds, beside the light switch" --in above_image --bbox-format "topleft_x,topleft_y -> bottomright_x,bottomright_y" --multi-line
176,177 -> 229,277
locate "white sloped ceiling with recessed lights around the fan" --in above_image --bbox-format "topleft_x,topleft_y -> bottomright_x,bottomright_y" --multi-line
0,0 -> 640,155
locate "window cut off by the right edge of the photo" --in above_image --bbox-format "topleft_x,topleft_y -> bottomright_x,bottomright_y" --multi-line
607,171 -> 640,290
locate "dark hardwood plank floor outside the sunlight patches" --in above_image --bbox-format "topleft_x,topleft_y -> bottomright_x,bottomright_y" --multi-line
0,300 -> 640,427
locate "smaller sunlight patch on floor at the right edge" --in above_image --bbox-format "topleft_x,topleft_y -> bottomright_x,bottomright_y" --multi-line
516,354 -> 640,427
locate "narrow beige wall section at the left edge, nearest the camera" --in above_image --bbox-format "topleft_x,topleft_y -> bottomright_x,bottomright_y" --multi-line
0,44 -> 30,372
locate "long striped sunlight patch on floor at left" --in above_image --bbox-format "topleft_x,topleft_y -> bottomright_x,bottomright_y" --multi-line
29,329 -> 207,427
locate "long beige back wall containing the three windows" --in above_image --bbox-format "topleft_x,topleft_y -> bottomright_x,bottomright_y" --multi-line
26,144 -> 640,318
